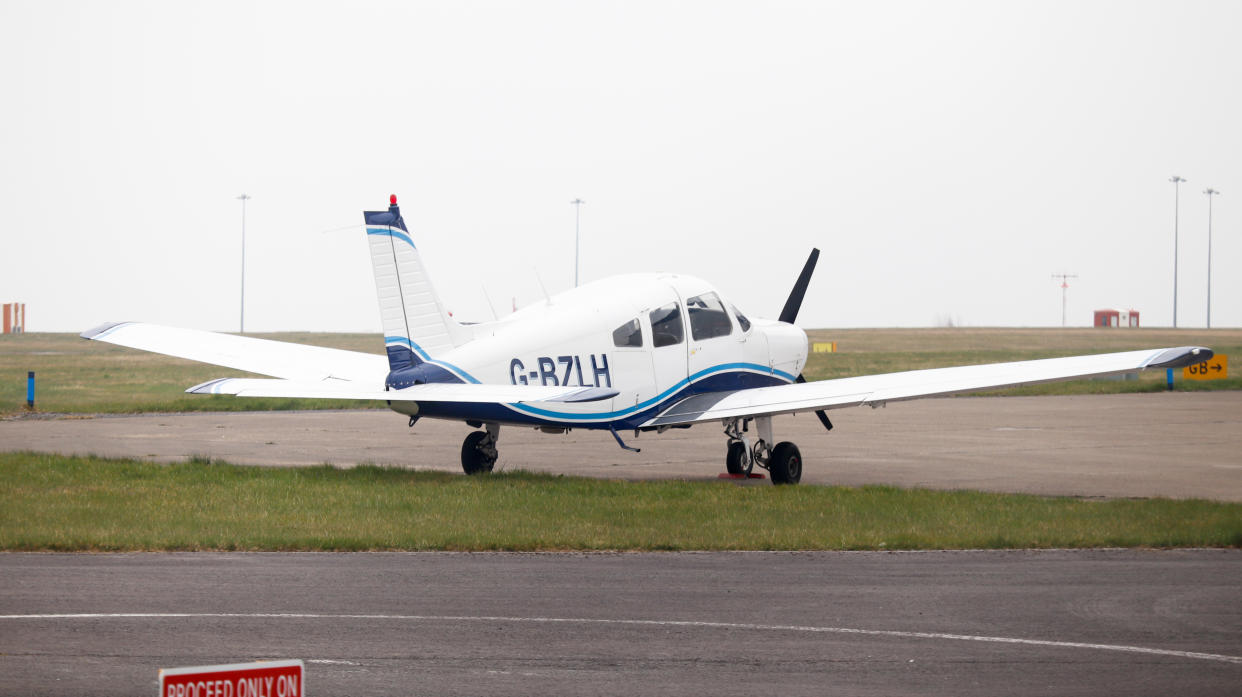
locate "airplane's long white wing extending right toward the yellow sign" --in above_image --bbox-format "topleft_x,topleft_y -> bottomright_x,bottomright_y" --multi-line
643,347 -> 1212,426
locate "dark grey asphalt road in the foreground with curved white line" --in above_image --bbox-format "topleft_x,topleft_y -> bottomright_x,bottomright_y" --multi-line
0,550 -> 1242,697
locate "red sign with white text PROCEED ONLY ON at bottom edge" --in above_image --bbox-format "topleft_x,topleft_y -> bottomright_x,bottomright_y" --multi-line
159,661 -> 307,697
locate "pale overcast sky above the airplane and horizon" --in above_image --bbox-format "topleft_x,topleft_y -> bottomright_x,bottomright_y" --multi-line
0,0 -> 1242,332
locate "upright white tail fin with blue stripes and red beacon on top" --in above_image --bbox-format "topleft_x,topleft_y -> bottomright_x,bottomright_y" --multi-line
363,195 -> 469,370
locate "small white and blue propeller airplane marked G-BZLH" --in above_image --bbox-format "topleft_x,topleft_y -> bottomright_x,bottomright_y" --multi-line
82,195 -> 1212,485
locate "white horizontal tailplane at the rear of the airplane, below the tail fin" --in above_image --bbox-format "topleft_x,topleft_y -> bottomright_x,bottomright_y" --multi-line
185,378 -> 620,404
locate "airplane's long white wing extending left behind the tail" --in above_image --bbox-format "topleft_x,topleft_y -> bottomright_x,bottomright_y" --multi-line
81,322 -> 389,380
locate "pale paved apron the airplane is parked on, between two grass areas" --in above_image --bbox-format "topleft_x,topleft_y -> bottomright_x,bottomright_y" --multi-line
0,391 -> 1242,501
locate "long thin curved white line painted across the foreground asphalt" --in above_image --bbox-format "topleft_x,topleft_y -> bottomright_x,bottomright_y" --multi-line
0,613 -> 1242,663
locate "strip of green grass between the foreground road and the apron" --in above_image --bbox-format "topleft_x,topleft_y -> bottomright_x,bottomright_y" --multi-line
0,453 -> 1242,552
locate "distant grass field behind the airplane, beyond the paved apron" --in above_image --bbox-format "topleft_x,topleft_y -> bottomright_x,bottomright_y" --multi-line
0,328 -> 1242,414
